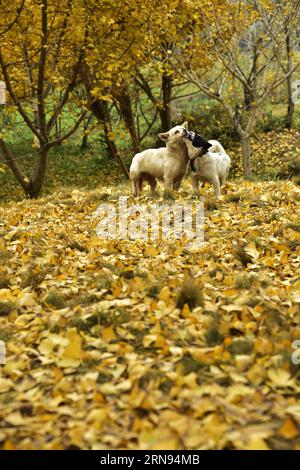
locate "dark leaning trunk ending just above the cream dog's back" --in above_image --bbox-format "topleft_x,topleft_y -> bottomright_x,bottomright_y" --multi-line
116,83 -> 141,153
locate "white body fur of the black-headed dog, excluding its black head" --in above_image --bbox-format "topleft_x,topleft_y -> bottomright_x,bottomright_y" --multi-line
185,139 -> 231,197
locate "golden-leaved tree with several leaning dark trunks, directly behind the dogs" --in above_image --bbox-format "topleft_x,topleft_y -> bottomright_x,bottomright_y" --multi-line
79,0 -> 189,158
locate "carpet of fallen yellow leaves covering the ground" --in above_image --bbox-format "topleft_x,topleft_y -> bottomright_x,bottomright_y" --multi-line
0,176 -> 300,449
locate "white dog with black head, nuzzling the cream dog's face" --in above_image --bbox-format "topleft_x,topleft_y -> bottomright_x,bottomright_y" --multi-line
185,132 -> 231,197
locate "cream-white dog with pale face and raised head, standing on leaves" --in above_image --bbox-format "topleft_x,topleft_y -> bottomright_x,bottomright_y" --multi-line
130,122 -> 189,196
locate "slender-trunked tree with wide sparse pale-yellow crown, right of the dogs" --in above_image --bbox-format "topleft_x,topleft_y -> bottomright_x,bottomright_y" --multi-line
174,0 -> 299,179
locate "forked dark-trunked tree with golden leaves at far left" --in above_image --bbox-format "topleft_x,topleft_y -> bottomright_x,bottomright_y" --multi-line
0,0 -> 86,197
